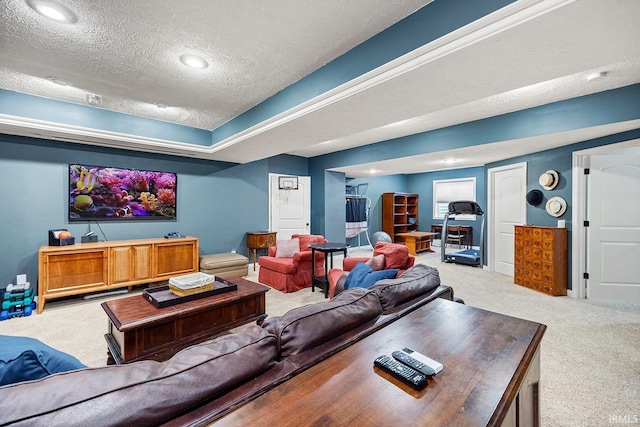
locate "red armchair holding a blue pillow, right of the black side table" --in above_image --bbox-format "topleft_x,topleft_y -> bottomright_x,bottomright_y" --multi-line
329,242 -> 416,298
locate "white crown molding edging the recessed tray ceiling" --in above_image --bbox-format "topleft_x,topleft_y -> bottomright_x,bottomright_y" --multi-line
0,0 -> 575,160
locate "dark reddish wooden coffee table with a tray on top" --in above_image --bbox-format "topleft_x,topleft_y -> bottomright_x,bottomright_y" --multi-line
101,277 -> 269,364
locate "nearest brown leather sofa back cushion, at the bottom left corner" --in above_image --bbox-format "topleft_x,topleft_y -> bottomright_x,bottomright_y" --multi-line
0,325 -> 277,426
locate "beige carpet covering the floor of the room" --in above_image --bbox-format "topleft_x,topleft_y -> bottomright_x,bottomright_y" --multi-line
0,247 -> 640,427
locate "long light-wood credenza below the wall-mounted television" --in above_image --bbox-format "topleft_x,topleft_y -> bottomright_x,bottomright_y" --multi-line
38,237 -> 198,313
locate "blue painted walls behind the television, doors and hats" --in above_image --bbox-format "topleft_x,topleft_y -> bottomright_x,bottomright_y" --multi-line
0,120 -> 640,296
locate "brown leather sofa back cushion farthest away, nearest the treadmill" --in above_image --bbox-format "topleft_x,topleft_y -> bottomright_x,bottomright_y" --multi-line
370,264 -> 440,311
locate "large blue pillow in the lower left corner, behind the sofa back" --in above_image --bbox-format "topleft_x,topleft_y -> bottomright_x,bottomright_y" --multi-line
0,335 -> 86,386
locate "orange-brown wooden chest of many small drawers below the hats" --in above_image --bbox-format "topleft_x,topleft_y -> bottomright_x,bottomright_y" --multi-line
513,225 -> 567,296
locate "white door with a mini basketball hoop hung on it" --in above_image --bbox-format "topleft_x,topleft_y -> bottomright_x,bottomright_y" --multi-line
269,174 -> 311,239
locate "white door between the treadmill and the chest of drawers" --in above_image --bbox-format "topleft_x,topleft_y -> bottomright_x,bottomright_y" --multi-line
487,162 -> 527,276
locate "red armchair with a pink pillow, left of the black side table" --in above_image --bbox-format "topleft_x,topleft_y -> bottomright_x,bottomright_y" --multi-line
258,234 -> 327,292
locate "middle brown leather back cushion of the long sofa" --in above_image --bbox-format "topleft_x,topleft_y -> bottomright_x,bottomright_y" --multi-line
262,288 -> 382,357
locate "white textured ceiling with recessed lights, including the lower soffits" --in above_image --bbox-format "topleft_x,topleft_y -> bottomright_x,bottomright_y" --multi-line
0,0 -> 640,177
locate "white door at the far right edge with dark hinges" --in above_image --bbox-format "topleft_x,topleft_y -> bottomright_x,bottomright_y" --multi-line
586,153 -> 640,300
